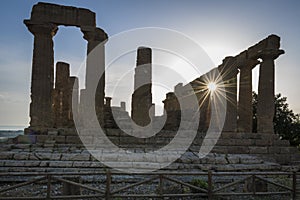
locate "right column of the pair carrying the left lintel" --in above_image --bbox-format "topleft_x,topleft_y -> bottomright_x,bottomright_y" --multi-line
81,27 -> 108,126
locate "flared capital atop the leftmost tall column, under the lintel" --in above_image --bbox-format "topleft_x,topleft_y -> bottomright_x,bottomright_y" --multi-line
24,20 -> 58,37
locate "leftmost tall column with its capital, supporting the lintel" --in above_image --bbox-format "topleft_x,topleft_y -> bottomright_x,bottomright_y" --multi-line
24,20 -> 58,128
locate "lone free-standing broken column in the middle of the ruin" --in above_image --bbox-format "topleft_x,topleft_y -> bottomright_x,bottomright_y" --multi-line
131,47 -> 152,126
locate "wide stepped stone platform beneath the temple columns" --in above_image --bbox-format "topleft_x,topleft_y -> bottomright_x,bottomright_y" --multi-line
0,129 -> 300,172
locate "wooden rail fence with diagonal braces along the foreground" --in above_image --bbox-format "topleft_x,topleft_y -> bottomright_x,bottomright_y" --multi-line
0,170 -> 299,200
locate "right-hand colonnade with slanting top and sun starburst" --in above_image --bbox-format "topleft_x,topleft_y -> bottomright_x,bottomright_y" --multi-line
163,35 -> 284,133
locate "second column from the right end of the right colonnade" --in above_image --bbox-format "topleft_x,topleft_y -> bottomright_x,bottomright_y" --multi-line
237,51 -> 259,133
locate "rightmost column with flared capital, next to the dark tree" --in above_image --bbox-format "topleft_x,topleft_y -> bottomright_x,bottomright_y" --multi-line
257,49 -> 284,133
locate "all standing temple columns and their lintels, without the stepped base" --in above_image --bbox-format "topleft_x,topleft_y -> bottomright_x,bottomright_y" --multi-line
24,3 -> 284,137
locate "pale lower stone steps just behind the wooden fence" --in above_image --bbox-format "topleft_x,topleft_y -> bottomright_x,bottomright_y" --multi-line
0,144 -> 292,172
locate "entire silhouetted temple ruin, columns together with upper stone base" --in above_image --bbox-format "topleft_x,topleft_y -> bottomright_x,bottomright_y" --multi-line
8,3 -> 300,170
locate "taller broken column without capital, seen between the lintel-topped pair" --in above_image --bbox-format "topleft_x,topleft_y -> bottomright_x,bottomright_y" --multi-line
53,62 -> 72,127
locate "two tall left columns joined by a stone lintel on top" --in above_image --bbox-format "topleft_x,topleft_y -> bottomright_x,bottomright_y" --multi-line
24,3 -> 108,132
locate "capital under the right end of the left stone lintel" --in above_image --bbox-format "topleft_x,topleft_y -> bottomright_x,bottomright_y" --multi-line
81,27 -> 108,42
